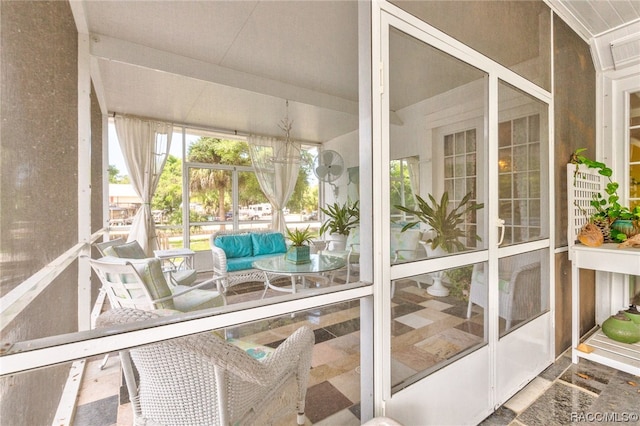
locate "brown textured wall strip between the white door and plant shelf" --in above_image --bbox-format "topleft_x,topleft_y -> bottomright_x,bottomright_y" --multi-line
553,18 -> 596,354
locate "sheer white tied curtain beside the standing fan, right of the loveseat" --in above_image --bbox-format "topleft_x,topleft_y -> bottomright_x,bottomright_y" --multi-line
247,135 -> 301,233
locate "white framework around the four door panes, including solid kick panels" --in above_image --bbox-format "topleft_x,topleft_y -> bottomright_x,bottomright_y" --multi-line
372,3 -> 555,423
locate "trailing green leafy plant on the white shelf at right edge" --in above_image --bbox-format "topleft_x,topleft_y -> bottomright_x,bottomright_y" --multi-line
571,148 -> 640,243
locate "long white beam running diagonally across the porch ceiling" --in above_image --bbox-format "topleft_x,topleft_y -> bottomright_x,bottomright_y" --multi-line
91,34 -> 358,116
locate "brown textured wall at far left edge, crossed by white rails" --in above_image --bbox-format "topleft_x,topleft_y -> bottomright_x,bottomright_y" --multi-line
0,1 -> 78,425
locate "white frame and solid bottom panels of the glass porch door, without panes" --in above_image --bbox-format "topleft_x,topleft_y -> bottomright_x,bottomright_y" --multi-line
372,2 -> 555,424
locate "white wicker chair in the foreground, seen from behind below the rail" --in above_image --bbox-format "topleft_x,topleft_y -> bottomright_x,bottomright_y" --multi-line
98,309 -> 315,425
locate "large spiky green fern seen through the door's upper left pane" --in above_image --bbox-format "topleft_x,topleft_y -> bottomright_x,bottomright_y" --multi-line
395,192 -> 484,253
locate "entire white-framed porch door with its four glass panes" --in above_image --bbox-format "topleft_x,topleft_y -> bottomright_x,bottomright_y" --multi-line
380,13 -> 552,424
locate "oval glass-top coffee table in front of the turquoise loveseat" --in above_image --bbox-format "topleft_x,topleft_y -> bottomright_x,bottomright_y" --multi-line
253,254 -> 347,297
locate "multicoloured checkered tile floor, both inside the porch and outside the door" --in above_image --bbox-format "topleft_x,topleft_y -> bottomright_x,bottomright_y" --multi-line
74,274 -> 640,426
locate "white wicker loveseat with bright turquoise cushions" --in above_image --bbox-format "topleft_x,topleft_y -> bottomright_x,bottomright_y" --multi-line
210,229 -> 287,291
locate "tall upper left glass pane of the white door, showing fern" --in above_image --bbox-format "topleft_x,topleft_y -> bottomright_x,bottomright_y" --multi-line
389,28 -> 487,263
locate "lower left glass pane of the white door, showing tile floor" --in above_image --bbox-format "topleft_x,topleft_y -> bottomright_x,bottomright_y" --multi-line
391,264 -> 487,390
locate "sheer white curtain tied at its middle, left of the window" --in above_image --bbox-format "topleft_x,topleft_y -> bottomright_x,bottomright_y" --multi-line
115,116 -> 173,256
